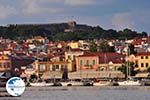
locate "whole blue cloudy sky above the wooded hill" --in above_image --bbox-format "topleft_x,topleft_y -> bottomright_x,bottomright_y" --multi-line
0,0 -> 150,33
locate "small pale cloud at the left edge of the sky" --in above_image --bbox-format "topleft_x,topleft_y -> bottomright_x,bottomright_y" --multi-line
0,4 -> 16,20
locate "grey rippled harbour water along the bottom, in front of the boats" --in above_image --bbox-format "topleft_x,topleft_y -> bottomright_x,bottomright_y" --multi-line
0,87 -> 150,100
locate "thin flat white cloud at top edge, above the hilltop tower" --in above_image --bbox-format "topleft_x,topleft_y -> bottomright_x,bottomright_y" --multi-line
65,0 -> 96,6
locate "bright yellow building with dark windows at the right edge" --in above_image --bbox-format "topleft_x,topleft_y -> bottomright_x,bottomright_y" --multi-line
135,52 -> 150,71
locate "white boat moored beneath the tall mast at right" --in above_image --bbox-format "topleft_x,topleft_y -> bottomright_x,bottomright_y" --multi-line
118,80 -> 141,86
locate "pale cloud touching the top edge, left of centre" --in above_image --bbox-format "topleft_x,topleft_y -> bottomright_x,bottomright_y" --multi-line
22,0 -> 63,16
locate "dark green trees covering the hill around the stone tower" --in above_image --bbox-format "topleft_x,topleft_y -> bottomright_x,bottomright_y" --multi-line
0,23 -> 147,41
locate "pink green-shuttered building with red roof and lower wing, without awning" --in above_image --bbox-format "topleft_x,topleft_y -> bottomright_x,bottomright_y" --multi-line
76,52 -> 125,71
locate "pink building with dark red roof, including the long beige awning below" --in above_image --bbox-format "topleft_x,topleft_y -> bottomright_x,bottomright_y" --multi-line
75,53 -> 125,78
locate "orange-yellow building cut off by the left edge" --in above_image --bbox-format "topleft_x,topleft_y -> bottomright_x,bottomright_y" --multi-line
0,55 -> 12,72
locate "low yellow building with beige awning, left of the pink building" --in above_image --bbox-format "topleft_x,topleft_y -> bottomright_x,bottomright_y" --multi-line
35,61 -> 73,79
